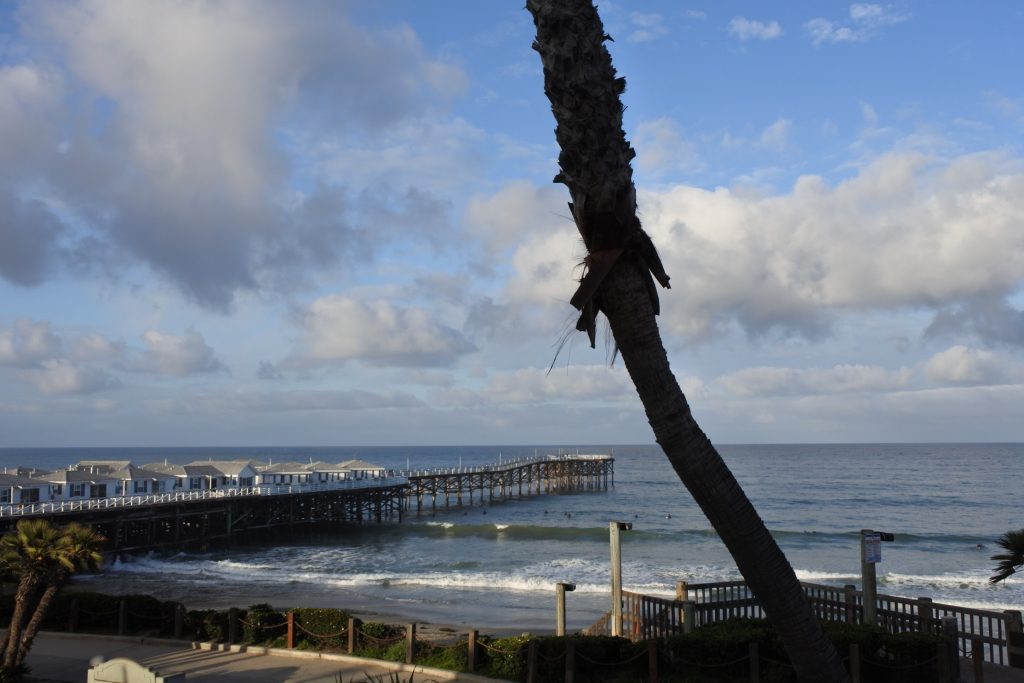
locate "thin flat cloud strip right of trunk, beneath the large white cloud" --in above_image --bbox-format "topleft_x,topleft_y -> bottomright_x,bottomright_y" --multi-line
718,366 -> 912,396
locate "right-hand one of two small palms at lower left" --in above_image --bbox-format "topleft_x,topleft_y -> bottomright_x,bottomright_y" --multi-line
13,523 -> 106,669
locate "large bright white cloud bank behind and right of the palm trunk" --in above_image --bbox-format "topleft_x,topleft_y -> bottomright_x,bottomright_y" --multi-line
504,153 -> 1024,341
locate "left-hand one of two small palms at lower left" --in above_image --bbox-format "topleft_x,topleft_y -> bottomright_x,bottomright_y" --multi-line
0,519 -> 61,673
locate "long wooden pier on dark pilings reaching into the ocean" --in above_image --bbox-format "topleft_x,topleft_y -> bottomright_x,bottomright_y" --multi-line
0,456 -> 614,553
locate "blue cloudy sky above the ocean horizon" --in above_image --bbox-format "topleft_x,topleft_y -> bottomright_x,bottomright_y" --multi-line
0,0 -> 1024,447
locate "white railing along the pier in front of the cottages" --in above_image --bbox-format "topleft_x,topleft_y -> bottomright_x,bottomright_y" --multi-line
0,476 -> 409,517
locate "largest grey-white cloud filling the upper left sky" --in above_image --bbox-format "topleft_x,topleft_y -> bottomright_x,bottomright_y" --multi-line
0,0 -> 466,309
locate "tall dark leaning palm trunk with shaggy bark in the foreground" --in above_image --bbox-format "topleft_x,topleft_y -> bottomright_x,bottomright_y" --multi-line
526,0 -> 848,683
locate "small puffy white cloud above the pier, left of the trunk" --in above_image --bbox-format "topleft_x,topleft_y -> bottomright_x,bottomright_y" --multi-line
282,295 -> 474,368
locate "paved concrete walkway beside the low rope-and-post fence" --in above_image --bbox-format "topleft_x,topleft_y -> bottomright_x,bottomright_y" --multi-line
28,633 -> 503,683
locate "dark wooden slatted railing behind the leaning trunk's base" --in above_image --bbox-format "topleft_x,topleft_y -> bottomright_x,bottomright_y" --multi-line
586,581 -> 1024,668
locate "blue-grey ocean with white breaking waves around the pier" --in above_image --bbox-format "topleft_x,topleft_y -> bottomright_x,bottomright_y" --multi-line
0,443 -> 1024,634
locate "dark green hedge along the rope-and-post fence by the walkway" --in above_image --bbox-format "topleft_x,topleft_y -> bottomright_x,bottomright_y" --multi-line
0,592 -> 948,683
